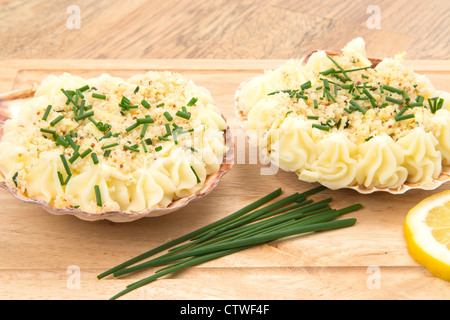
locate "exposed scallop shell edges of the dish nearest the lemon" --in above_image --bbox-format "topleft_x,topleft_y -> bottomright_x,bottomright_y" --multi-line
234,51 -> 450,194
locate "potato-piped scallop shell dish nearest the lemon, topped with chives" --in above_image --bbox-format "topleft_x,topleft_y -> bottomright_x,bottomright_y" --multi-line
235,38 -> 450,193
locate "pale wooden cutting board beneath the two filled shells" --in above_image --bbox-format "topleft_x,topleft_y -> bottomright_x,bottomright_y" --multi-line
0,60 -> 450,299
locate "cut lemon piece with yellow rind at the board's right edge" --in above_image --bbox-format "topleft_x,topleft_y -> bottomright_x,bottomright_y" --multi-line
404,190 -> 450,281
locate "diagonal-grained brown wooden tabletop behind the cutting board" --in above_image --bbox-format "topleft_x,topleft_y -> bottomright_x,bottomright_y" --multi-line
0,0 -> 450,59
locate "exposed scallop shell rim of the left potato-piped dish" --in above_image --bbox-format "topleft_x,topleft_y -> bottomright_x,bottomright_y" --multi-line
0,89 -> 235,222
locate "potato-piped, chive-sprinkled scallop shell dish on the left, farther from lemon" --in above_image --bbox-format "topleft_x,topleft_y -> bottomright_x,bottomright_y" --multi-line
0,71 -> 234,222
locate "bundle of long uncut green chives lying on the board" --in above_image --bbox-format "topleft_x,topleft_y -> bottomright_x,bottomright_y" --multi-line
98,186 -> 361,299
